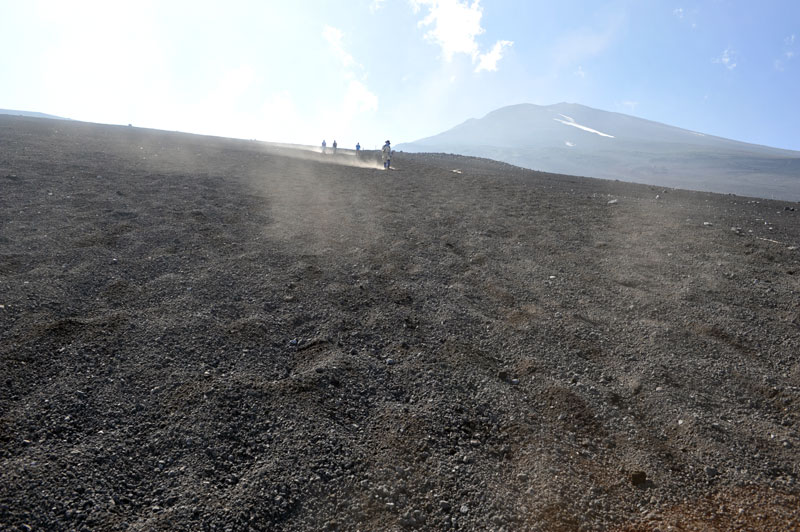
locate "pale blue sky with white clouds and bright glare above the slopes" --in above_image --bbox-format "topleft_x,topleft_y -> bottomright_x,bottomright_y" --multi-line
0,0 -> 800,150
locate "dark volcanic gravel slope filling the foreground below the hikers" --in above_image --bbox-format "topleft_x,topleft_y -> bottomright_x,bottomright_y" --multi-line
0,116 -> 800,532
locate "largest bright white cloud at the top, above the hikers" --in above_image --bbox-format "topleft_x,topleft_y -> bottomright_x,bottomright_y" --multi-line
410,0 -> 514,72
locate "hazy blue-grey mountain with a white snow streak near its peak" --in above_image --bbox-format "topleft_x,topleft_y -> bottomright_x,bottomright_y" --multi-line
397,103 -> 800,201
